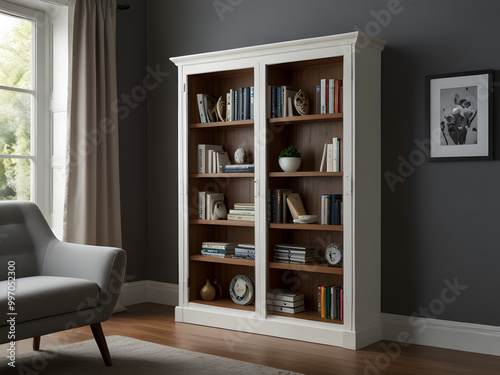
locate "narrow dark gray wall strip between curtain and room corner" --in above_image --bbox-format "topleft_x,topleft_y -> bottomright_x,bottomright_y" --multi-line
116,0 -> 148,281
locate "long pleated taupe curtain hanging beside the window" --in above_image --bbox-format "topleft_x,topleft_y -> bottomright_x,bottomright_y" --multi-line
63,0 -> 122,247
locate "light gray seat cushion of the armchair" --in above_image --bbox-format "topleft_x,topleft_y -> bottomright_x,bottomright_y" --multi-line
0,276 -> 99,326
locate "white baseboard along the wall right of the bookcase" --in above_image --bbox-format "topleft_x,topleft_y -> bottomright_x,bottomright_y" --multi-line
382,313 -> 500,355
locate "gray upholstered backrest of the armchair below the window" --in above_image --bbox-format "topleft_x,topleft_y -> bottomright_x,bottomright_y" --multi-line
0,201 -> 56,280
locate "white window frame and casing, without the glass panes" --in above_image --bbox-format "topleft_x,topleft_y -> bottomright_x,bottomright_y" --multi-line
0,0 -> 69,238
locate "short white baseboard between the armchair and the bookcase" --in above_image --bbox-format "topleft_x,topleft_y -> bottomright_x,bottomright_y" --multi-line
121,280 -> 179,306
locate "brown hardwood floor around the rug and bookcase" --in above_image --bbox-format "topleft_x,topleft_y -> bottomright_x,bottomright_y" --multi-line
4,303 -> 500,375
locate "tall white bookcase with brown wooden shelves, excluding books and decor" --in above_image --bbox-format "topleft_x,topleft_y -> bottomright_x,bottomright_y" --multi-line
171,32 -> 385,349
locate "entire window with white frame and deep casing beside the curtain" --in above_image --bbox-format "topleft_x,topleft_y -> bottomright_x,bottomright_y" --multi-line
0,0 -> 68,237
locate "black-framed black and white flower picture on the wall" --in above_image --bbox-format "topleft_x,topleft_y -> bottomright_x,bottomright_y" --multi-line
425,70 -> 493,161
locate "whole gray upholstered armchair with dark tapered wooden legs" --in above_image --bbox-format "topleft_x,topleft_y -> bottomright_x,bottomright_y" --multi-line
0,201 -> 126,366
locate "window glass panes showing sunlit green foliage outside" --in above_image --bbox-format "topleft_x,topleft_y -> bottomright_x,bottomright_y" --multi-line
0,13 -> 37,200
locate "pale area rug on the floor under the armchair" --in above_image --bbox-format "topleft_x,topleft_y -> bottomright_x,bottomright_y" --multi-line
0,336 -> 300,375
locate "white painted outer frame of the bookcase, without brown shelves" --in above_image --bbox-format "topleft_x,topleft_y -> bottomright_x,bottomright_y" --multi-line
171,32 -> 384,349
